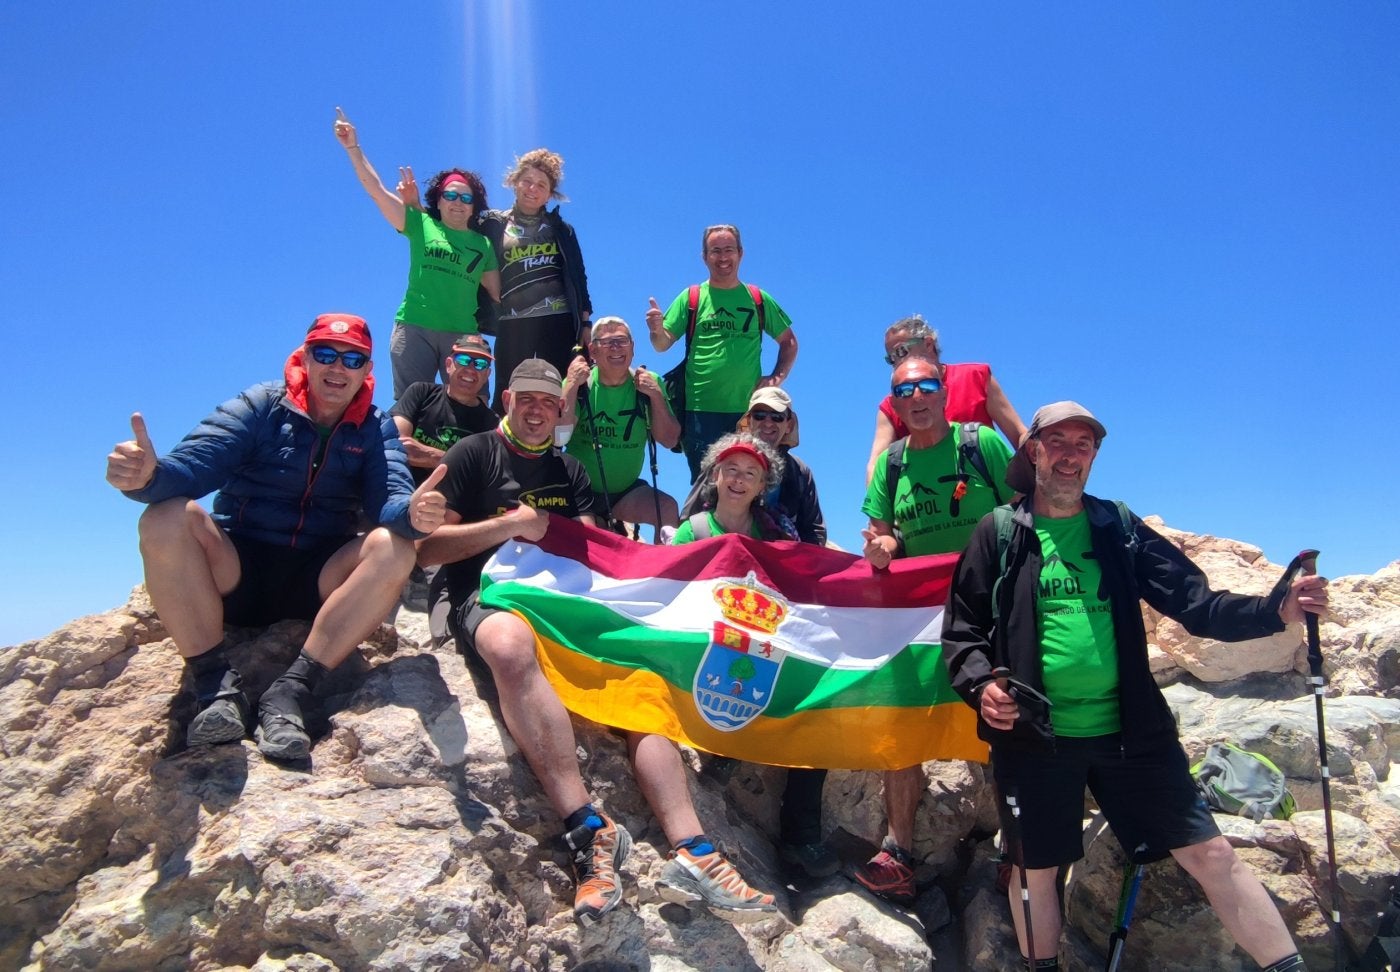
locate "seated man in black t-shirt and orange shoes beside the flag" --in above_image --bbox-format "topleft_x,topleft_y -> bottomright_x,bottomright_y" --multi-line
419,359 -> 777,924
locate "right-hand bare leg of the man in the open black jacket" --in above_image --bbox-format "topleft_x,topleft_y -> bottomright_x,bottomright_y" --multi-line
1172,836 -> 1298,965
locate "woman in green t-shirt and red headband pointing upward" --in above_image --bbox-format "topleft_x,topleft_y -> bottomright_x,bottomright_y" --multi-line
335,108 -> 508,398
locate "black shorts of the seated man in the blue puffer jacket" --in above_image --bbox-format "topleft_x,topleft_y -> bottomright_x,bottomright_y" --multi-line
224,534 -> 353,627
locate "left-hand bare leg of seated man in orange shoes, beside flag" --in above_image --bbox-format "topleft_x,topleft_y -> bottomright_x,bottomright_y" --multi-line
476,612 -> 589,818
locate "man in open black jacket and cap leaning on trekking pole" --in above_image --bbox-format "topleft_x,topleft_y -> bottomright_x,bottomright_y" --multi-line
942,402 -> 1327,972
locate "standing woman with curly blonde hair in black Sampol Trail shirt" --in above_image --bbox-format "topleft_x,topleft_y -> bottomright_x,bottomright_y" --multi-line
482,148 -> 594,412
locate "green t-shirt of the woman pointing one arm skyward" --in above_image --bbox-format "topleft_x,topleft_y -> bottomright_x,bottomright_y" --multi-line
393,209 -> 497,335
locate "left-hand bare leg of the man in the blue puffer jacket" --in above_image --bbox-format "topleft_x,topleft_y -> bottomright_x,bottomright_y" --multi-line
139,499 -> 239,658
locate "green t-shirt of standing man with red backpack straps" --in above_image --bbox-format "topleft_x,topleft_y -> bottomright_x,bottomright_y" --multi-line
664,283 -> 792,412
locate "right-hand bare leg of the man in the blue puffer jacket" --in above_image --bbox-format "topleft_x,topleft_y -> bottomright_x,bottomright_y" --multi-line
305,527 -> 414,668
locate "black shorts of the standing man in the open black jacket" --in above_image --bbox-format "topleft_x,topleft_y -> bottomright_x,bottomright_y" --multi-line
991,733 -> 1219,870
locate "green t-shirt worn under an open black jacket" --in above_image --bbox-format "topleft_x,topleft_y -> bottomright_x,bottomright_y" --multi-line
1036,511 -> 1120,738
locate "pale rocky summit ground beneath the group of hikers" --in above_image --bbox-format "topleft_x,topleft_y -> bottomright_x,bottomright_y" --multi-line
0,522 -> 1400,972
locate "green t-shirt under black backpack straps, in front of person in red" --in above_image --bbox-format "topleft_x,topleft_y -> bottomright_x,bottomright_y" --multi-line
861,422 -> 1011,557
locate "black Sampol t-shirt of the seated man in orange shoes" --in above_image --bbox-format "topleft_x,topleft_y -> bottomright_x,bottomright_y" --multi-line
438,430 -> 594,604
